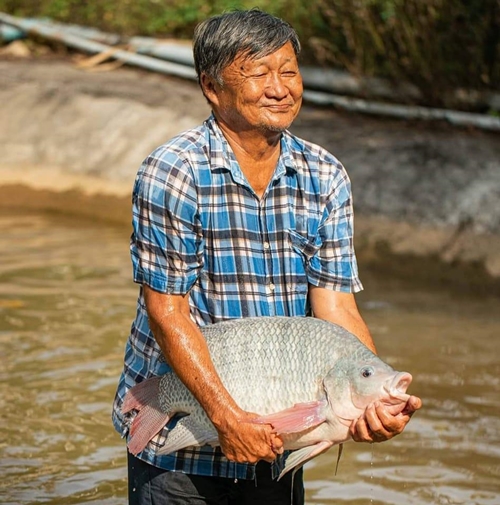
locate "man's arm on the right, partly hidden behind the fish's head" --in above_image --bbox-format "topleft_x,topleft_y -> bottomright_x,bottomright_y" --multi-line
309,286 -> 422,442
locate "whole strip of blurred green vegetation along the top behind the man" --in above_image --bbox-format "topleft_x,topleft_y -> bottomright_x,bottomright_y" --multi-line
0,0 -> 500,106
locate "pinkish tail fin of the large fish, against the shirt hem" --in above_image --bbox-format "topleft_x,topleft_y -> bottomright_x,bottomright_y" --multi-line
122,377 -> 171,456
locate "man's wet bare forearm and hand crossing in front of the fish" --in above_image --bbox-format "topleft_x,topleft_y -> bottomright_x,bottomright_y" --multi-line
143,286 -> 283,463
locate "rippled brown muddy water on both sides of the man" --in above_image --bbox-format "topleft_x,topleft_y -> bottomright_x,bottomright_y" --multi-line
0,211 -> 500,505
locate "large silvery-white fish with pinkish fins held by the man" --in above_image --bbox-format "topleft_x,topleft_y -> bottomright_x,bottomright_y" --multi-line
122,317 -> 412,475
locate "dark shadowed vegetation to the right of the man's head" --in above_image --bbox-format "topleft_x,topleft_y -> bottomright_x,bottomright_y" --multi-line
312,0 -> 500,105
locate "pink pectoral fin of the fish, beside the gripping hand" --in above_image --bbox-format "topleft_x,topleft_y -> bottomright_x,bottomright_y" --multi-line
252,400 -> 327,435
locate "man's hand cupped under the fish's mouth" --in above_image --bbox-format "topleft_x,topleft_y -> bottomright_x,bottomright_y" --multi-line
349,396 -> 422,442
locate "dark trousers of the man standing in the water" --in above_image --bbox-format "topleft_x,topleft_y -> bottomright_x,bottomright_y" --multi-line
128,453 -> 304,505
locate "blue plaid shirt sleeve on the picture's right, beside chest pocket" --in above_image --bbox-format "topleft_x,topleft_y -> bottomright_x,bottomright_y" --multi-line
307,160 -> 363,293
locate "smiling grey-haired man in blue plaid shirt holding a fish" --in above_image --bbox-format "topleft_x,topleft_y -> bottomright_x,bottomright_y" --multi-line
113,10 -> 420,505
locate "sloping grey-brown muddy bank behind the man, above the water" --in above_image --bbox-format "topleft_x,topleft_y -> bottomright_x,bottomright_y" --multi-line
0,59 -> 500,294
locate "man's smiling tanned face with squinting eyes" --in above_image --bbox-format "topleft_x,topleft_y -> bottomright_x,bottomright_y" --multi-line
202,43 -> 303,133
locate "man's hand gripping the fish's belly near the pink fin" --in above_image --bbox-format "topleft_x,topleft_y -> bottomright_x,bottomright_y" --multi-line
217,411 -> 284,463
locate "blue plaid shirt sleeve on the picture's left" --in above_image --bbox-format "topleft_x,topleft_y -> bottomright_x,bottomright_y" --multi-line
130,147 -> 203,294
